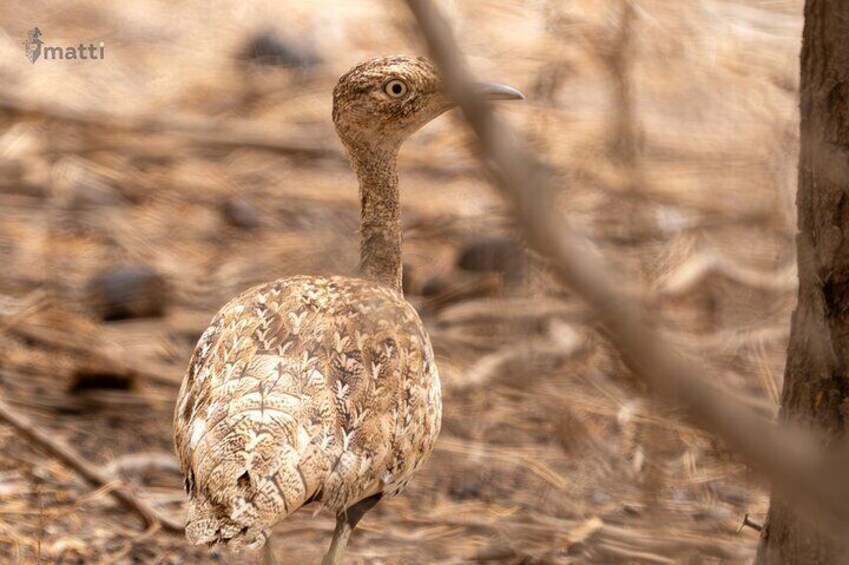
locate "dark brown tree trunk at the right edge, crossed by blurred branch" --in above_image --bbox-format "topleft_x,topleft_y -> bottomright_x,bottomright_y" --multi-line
758,0 -> 849,565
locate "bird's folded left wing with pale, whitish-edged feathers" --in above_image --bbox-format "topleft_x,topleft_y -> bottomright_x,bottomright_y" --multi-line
174,282 -> 335,543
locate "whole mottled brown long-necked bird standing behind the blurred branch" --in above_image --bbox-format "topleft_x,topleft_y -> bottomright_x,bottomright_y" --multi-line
173,55 -> 524,565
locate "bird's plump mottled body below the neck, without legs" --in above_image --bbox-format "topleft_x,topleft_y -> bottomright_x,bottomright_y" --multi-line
174,276 -> 442,547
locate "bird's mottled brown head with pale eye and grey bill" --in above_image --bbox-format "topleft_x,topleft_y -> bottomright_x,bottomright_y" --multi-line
333,55 -> 524,151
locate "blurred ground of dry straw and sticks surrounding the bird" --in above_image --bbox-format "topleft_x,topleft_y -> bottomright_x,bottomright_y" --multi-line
0,0 -> 802,563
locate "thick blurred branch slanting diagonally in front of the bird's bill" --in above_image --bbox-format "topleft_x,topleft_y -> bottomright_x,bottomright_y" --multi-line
406,0 -> 849,532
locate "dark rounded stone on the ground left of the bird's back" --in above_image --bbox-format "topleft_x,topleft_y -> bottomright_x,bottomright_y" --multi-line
87,265 -> 168,321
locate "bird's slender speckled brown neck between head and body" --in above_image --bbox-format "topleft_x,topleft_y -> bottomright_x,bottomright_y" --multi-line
350,143 -> 403,293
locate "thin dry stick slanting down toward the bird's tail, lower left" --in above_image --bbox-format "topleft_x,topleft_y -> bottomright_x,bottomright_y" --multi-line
0,394 -> 183,532
